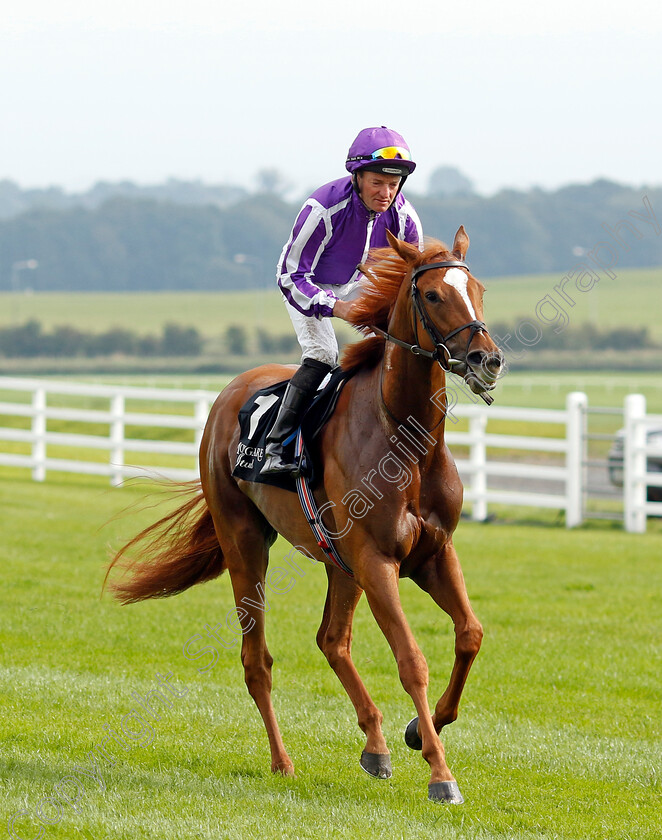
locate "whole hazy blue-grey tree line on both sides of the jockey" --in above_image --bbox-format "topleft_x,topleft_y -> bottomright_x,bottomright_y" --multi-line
0,173 -> 662,291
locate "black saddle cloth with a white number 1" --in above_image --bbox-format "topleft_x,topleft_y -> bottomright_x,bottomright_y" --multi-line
232,367 -> 355,493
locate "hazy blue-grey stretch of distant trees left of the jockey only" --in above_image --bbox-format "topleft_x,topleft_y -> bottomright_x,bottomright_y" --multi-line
0,196 -> 288,292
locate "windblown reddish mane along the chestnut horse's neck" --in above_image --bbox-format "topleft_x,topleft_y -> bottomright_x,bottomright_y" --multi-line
341,239 -> 452,370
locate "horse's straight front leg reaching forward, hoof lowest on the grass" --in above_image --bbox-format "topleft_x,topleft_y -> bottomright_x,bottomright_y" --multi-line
355,555 -> 464,803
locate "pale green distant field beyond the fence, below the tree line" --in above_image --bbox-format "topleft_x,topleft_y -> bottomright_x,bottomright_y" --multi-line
0,267 -> 662,339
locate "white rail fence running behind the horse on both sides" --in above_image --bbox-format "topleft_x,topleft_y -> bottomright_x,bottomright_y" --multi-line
0,377 -> 662,531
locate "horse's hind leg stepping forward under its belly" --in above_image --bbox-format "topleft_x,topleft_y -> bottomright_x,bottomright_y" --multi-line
317,566 -> 391,779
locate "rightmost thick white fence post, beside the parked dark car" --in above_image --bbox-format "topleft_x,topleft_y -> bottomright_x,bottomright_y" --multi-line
623,394 -> 646,534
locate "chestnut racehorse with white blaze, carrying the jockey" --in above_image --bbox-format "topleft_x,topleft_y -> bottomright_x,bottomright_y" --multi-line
109,227 -> 502,803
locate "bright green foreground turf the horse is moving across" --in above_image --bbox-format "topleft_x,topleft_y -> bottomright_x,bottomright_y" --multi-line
0,471 -> 662,840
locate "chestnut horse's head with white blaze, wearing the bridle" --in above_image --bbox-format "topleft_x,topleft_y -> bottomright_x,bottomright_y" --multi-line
389,226 -> 503,394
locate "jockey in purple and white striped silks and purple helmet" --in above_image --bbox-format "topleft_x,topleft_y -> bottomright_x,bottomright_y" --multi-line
262,126 -> 423,473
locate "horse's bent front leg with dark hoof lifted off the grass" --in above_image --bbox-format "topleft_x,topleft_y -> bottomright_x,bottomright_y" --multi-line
406,542 -> 483,749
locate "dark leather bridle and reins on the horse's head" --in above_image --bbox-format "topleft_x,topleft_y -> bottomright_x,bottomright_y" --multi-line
370,260 -> 493,413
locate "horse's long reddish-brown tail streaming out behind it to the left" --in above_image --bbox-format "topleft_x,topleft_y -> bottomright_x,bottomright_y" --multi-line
104,481 -> 225,604
